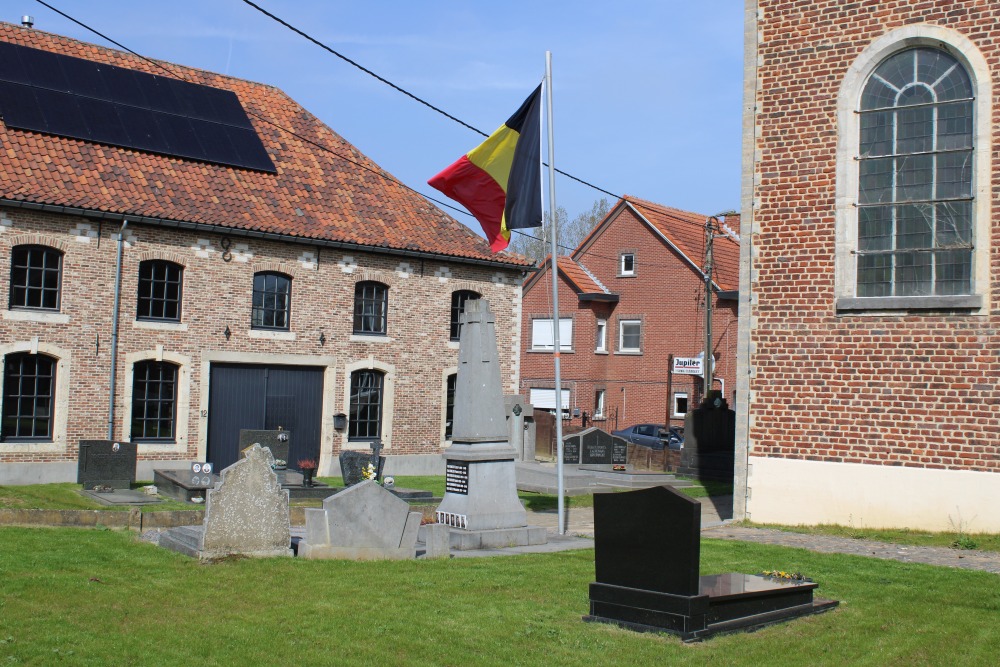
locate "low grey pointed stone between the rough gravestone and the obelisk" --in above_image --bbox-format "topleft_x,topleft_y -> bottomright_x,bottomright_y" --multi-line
298,480 -> 423,560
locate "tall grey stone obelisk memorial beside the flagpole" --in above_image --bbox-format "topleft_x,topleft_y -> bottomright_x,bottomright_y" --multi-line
436,299 -> 547,550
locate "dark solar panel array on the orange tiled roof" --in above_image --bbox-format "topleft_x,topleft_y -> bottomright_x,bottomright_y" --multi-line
0,42 -> 275,173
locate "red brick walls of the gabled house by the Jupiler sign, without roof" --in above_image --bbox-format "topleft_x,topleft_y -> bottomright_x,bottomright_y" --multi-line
521,208 -> 737,430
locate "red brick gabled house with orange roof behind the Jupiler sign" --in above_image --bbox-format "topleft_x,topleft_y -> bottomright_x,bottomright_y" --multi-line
521,197 -> 739,430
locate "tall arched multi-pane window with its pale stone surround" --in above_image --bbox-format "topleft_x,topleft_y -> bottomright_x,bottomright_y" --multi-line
836,25 -> 992,311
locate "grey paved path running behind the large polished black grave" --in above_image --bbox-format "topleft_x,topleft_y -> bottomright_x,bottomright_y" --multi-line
528,497 -> 1000,574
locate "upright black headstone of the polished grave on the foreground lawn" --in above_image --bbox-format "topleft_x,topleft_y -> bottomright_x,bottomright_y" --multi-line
594,486 -> 701,595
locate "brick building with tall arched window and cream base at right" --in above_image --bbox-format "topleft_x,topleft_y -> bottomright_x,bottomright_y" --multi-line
737,0 -> 1000,532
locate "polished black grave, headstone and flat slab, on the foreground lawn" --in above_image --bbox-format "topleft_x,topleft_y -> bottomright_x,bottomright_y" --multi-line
584,486 -> 838,641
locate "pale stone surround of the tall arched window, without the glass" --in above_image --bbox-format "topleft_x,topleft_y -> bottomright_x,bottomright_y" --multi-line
835,24 -> 993,314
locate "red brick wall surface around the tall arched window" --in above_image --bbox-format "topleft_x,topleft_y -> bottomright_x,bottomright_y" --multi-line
748,0 -> 1000,472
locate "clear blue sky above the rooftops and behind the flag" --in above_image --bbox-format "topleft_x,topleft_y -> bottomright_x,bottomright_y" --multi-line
0,0 -> 743,232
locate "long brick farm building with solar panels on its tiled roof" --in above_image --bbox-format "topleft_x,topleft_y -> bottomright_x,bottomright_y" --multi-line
0,24 -> 527,483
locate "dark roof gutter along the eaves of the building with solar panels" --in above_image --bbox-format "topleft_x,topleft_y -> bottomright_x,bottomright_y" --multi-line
0,198 -> 537,272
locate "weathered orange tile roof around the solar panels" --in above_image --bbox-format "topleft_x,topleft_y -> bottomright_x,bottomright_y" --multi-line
0,23 -> 531,267
